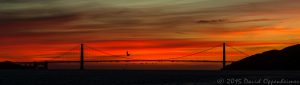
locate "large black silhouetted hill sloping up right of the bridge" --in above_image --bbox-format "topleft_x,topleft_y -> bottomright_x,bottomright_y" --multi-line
223,44 -> 300,70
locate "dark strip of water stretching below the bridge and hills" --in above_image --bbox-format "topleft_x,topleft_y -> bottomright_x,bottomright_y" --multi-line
0,70 -> 300,85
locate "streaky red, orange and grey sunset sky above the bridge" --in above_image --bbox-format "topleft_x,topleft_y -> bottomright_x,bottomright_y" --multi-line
0,0 -> 300,61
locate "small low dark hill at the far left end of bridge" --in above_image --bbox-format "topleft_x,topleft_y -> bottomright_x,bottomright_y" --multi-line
0,61 -> 26,69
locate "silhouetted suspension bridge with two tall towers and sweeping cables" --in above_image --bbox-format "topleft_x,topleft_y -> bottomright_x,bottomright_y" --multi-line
15,43 -> 249,70
